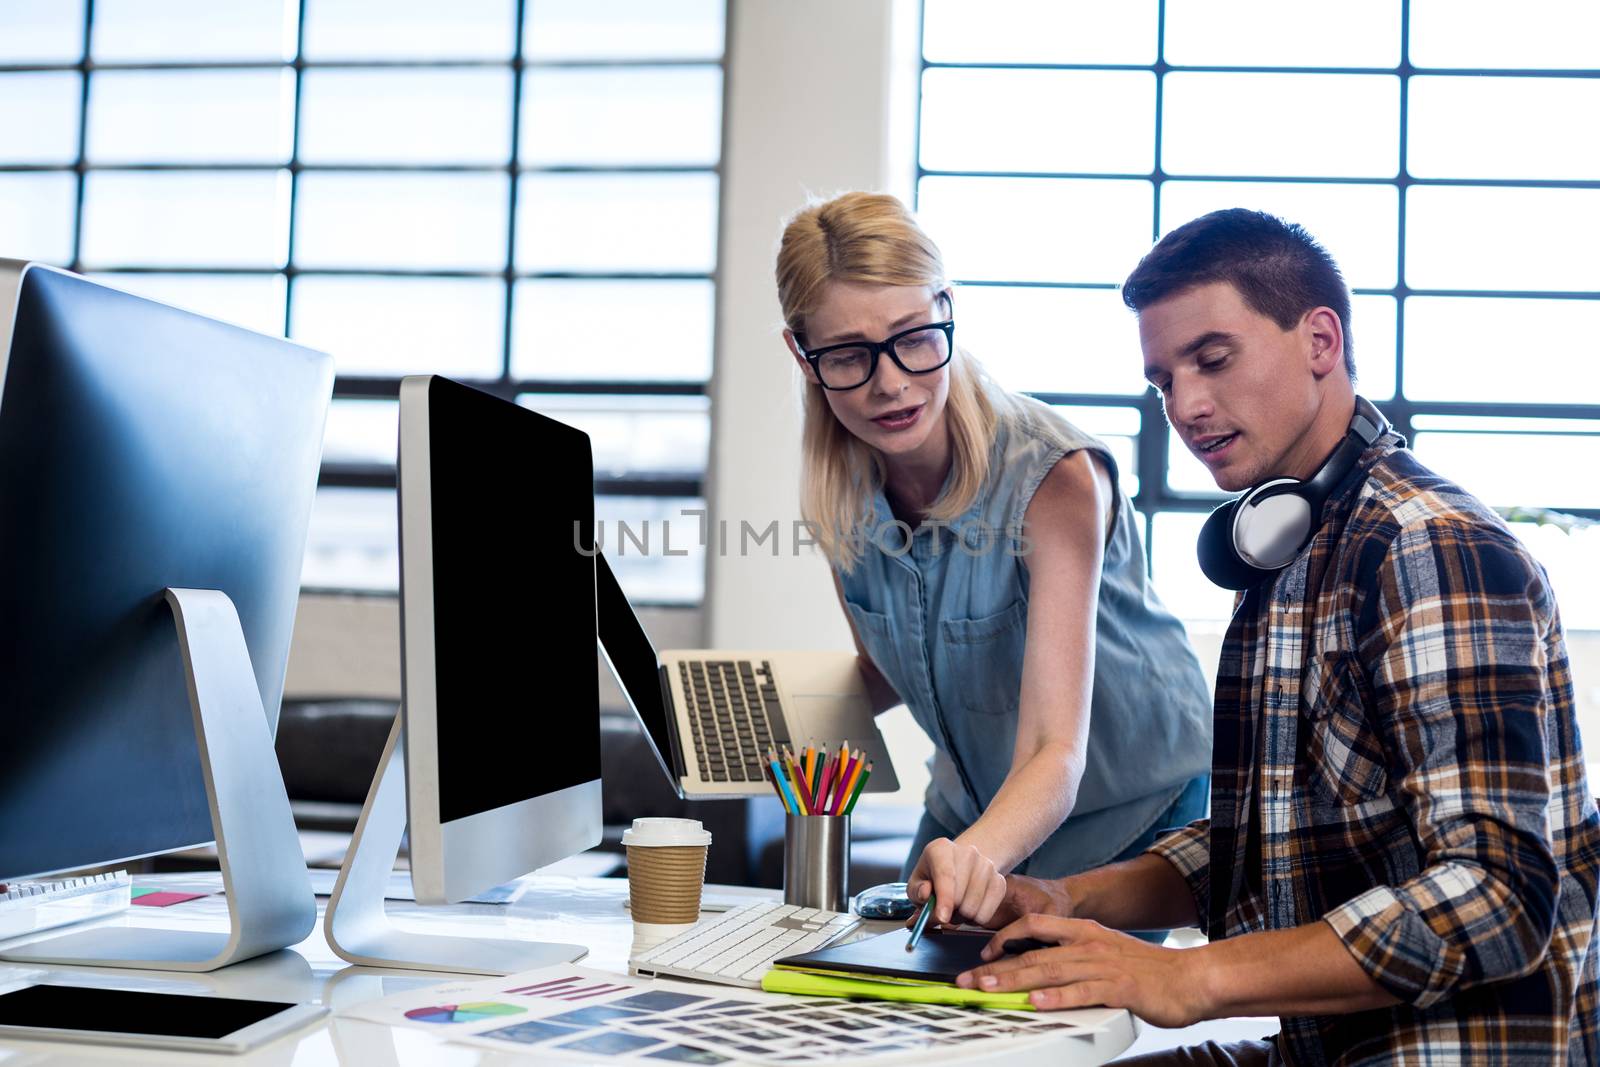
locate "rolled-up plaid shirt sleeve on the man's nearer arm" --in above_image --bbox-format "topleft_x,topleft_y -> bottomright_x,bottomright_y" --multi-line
1323,515 -> 1560,1008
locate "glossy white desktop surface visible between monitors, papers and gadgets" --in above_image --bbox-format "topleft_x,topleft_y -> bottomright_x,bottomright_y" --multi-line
0,875 -> 1136,1067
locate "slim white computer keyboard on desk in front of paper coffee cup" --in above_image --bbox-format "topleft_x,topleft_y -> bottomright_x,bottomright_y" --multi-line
627,901 -> 861,989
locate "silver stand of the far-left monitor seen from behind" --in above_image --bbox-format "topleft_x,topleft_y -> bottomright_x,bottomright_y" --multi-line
0,589 -> 317,971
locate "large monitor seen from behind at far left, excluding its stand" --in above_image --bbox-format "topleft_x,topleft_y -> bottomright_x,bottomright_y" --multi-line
0,259 -> 333,966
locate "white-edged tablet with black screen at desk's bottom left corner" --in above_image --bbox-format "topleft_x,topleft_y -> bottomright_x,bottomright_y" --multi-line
0,985 -> 328,1053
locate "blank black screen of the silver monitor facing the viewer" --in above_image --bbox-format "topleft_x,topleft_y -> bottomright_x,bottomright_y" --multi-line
429,378 -> 600,822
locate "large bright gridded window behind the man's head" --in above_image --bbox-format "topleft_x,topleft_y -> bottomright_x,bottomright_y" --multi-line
917,0 -> 1600,629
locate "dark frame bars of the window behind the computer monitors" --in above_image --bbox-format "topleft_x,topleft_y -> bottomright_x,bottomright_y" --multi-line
0,0 -> 728,498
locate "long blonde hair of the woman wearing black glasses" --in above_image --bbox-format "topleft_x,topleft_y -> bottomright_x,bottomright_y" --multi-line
778,192 -> 1003,571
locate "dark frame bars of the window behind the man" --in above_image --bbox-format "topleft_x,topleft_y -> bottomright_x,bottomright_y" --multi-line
912,0 -> 1600,565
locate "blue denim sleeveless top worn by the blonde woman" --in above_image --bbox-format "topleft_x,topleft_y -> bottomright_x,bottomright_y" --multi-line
838,397 -> 1211,877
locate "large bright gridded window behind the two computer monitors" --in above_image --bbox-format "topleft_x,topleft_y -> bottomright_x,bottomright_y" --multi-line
0,0 -> 725,601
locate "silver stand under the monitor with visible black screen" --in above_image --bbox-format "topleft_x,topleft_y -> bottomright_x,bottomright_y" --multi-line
323,715 -> 589,974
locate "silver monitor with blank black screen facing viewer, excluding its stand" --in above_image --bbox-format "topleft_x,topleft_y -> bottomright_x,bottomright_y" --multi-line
398,378 -> 602,904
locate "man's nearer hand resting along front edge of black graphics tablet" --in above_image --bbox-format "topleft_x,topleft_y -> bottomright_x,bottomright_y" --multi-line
955,915 -> 1208,1027
